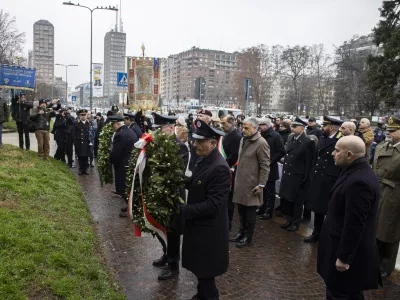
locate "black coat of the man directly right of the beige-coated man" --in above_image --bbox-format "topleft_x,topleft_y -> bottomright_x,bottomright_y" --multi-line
261,127 -> 286,181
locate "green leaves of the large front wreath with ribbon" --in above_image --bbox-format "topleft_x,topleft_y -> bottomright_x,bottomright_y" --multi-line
127,131 -> 185,235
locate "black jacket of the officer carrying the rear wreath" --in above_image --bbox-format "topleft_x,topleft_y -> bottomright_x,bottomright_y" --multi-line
110,125 -> 139,167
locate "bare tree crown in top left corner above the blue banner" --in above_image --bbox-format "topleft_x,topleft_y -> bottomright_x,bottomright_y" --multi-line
0,9 -> 25,64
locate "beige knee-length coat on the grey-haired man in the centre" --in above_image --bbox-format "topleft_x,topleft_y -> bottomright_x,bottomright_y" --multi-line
233,132 -> 270,206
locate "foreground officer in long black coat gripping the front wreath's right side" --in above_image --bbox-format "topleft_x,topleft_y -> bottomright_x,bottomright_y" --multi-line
182,120 -> 231,300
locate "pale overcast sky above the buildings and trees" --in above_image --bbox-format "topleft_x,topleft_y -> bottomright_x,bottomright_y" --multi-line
0,0 -> 381,87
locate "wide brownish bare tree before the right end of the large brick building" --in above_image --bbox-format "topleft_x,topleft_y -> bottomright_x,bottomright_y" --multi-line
234,44 -> 282,113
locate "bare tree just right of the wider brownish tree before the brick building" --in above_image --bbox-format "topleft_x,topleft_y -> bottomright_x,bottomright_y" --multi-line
281,45 -> 310,112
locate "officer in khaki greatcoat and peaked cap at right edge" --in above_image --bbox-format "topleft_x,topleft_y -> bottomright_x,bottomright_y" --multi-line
373,116 -> 400,277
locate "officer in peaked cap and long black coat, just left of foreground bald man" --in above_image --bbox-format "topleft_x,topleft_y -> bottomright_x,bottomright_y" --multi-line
304,116 -> 343,243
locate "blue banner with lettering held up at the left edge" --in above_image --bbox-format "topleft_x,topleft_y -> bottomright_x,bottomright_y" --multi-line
0,65 -> 36,91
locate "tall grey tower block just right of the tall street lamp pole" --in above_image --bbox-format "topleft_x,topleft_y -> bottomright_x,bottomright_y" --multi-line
103,30 -> 126,103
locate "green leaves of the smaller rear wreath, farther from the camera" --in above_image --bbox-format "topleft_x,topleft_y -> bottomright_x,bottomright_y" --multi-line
97,124 -> 114,187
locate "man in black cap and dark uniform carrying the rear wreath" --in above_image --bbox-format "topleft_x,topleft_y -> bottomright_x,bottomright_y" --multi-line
109,115 -> 139,211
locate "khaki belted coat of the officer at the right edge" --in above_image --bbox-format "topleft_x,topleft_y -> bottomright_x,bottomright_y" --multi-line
372,142 -> 400,243
